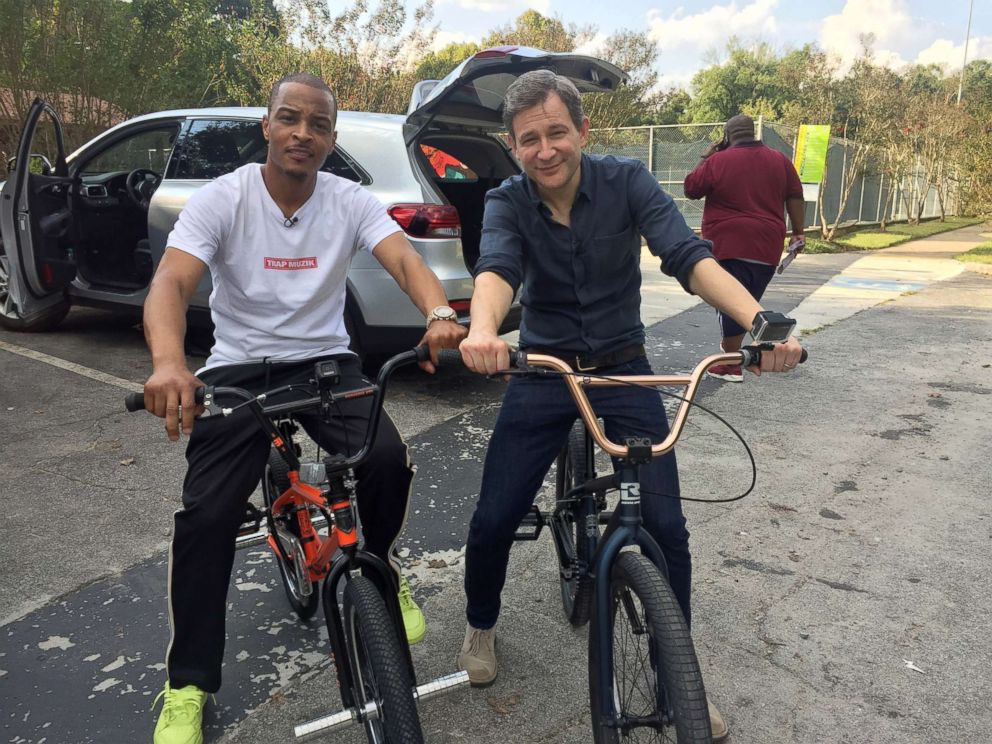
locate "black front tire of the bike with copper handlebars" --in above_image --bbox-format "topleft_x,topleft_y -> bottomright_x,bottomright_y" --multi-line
589,552 -> 713,744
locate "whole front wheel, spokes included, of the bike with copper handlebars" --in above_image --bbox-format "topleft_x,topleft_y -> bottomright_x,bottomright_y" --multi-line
589,552 -> 713,744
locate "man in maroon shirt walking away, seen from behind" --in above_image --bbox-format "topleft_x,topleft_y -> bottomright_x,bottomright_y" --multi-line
685,115 -> 806,382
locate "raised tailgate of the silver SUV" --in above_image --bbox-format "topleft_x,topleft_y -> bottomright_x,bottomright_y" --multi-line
406,46 -> 628,143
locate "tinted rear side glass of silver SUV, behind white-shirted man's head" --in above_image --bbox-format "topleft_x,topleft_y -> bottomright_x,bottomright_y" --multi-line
168,119 -> 372,184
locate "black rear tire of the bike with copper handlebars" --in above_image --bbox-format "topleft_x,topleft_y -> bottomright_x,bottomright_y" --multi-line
555,421 -> 593,628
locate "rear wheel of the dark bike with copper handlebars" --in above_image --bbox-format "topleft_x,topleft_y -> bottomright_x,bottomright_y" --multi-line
555,421 -> 599,628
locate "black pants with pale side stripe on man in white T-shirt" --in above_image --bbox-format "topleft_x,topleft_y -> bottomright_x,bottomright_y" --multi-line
166,355 -> 413,692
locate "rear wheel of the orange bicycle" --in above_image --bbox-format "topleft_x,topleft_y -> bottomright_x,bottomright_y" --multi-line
262,449 -> 320,621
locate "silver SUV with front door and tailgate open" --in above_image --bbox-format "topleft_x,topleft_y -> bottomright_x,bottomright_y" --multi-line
0,47 -> 626,355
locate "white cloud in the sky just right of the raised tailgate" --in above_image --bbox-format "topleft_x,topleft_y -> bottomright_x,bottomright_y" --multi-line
648,0 -> 779,54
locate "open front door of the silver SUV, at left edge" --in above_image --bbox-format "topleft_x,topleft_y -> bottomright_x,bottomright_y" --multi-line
0,98 -> 76,331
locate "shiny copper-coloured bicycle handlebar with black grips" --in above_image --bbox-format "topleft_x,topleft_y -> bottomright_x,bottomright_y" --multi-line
437,346 -> 809,459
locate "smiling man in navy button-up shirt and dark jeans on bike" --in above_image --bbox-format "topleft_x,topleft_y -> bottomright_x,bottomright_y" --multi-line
458,70 -> 802,737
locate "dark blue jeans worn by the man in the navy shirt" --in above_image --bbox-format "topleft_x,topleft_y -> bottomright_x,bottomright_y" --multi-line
465,357 -> 692,629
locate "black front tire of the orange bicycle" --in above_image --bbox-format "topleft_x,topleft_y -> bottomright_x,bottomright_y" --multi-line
343,576 -> 424,744
